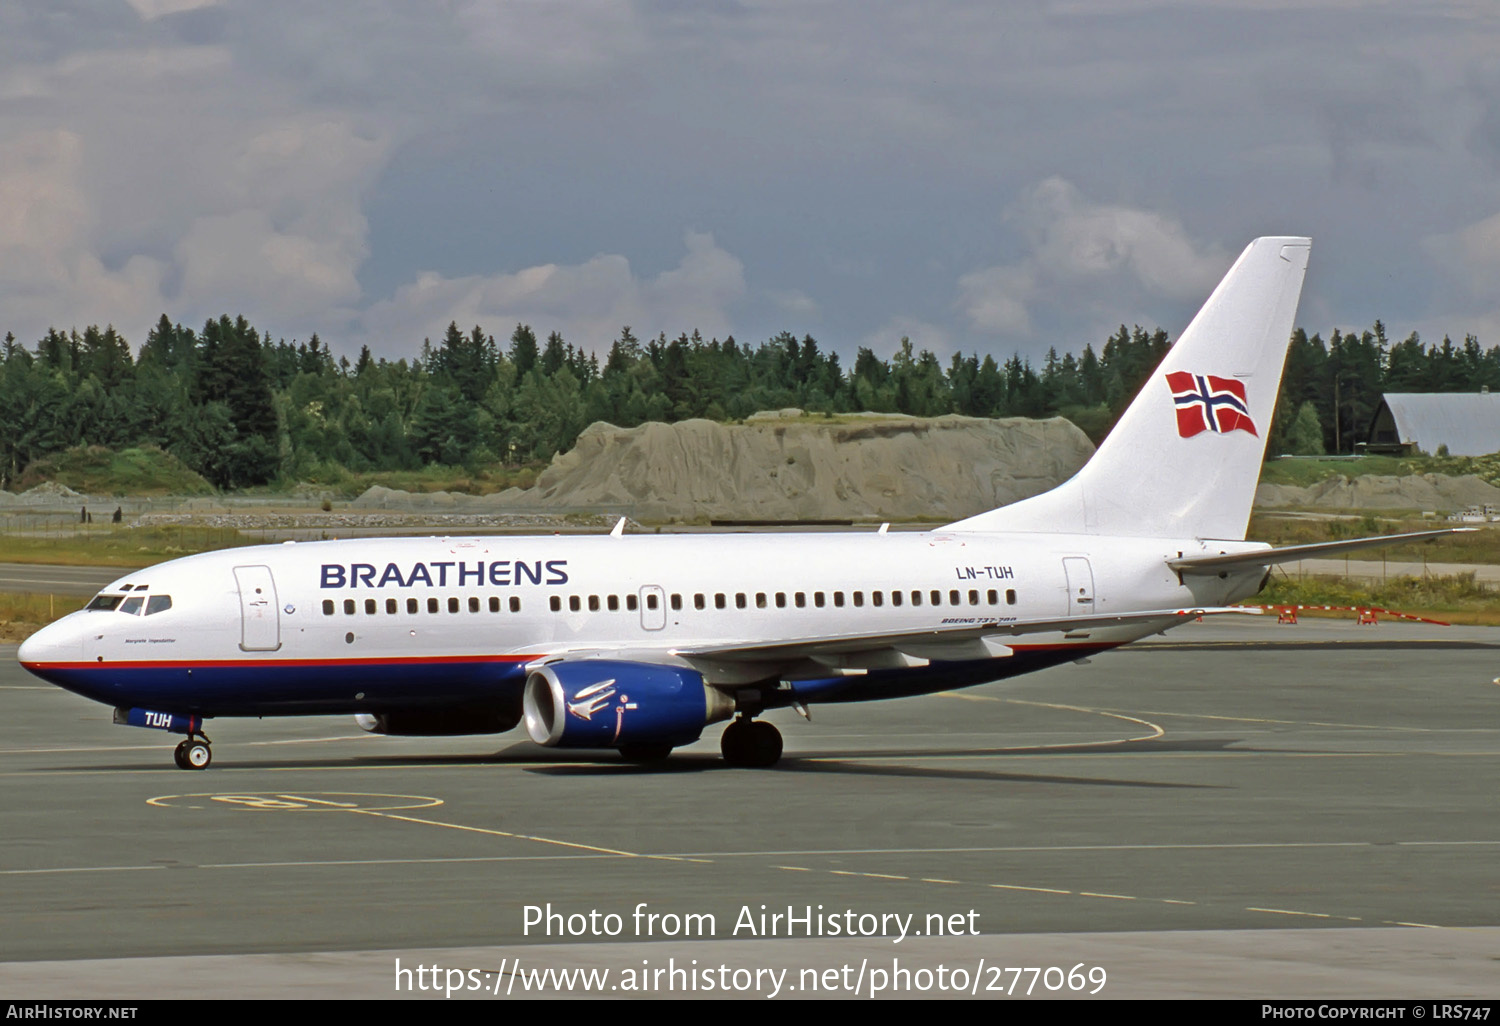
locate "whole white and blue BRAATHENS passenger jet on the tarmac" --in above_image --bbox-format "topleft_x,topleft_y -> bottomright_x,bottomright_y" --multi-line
18,237 -> 1448,770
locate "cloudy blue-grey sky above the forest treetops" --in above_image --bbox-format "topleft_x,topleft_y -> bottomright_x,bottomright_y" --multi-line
0,0 -> 1500,362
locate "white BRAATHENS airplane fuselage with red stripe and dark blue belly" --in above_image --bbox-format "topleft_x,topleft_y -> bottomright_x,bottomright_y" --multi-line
21,531 -> 1256,716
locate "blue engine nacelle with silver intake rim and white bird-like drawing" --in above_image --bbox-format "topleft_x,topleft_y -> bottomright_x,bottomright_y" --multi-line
524,659 -> 735,749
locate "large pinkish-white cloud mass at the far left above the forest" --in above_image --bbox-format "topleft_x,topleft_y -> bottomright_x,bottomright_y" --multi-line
0,47 -> 390,342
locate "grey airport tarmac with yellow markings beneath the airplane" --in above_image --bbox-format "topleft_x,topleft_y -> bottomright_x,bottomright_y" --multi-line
0,617 -> 1500,1001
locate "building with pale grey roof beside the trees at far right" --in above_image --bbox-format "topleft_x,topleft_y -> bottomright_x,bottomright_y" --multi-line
1365,390 -> 1500,456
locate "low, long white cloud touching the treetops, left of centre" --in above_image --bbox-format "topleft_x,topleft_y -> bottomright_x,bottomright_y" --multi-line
362,233 -> 746,356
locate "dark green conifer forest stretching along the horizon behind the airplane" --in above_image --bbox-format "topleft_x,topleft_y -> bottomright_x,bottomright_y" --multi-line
0,314 -> 1500,489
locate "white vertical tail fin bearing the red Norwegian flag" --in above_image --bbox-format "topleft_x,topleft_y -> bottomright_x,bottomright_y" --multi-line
947,237 -> 1311,539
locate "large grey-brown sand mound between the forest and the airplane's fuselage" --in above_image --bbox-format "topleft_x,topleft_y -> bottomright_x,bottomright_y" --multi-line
354,411 -> 1094,521
